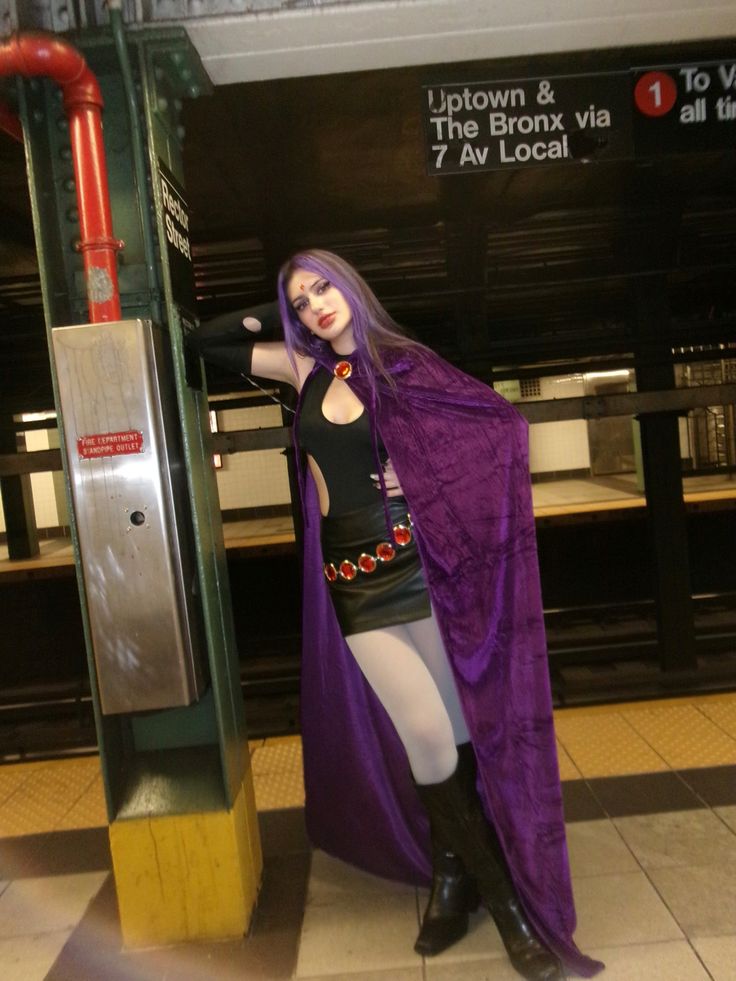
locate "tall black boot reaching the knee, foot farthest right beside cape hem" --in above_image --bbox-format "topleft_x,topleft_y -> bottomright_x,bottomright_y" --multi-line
417,745 -> 565,981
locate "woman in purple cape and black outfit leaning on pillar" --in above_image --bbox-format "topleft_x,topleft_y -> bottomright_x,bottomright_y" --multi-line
192,251 -> 602,981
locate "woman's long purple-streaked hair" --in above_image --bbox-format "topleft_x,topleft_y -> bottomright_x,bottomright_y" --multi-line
278,249 -> 422,384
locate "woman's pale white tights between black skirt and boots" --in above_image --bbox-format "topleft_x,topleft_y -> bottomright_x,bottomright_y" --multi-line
345,615 -> 469,784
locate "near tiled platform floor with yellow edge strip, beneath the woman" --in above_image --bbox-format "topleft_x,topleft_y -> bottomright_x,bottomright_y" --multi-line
0,694 -> 736,981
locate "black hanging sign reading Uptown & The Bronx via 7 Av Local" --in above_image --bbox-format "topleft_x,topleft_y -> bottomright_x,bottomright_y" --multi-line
422,62 -> 736,175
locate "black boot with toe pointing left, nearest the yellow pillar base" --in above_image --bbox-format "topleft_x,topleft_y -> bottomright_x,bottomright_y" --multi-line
414,747 -> 480,957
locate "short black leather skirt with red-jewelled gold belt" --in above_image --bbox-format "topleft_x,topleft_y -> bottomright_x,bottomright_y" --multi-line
321,497 -> 432,637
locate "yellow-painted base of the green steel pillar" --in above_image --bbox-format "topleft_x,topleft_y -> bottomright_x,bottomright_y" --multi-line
109,778 -> 263,948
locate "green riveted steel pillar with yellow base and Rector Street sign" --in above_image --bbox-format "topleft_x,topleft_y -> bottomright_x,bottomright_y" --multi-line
18,23 -> 262,946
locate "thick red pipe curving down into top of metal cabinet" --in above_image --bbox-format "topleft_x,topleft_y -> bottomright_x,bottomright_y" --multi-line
0,34 -> 123,323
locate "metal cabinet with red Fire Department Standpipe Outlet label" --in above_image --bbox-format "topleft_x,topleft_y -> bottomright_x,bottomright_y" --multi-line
52,320 -> 206,714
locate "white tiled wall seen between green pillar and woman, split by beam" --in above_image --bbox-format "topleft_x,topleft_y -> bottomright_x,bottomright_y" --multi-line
217,405 -> 291,510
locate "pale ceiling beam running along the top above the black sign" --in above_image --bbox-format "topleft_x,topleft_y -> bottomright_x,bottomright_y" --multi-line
134,0 -> 736,85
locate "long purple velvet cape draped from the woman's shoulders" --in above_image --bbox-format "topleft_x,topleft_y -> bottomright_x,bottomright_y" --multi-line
294,349 -> 602,977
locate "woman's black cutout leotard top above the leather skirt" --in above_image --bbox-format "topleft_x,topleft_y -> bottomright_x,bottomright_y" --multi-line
299,368 -> 386,517
